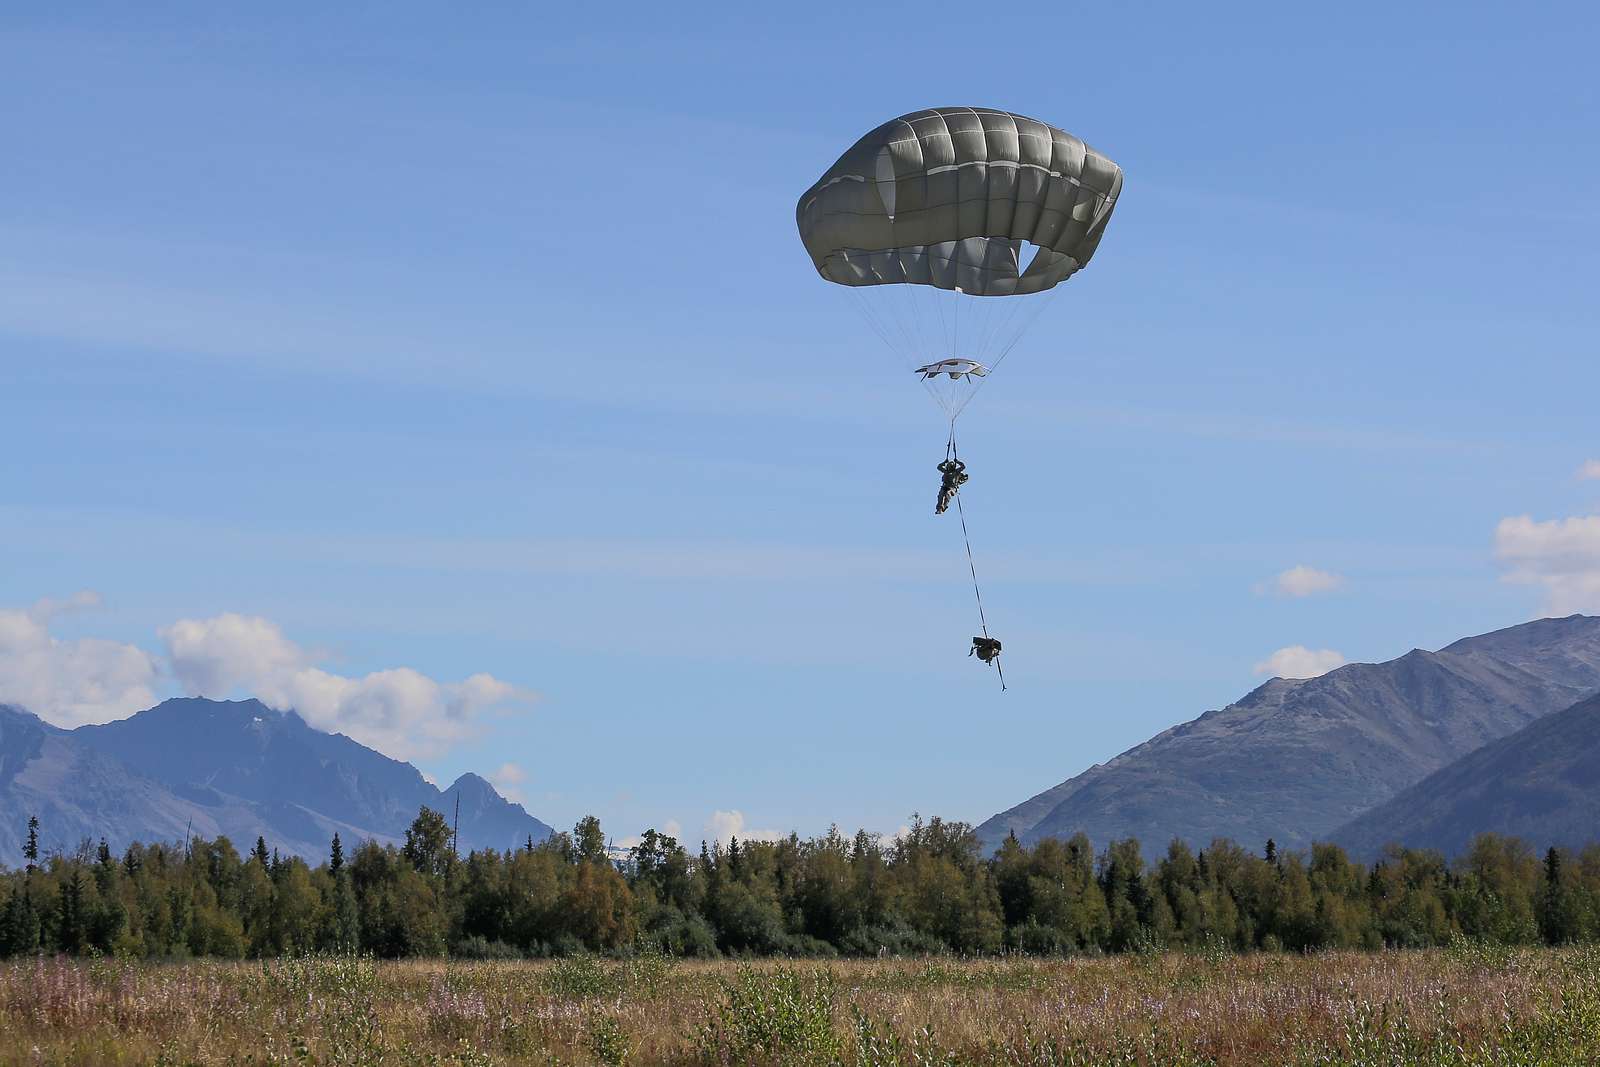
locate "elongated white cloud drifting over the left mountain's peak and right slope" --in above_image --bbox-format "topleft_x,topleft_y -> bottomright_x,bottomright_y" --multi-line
160,613 -> 533,760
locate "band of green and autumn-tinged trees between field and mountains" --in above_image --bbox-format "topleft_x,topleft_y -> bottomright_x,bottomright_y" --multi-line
0,808 -> 1600,958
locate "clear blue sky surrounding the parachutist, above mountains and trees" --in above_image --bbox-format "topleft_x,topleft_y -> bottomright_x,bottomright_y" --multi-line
0,3 -> 1600,840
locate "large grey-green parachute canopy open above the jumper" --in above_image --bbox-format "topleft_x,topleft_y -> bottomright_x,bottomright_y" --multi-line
795,107 -> 1122,296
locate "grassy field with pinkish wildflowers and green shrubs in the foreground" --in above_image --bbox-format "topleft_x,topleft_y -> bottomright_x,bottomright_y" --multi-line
0,945 -> 1600,1067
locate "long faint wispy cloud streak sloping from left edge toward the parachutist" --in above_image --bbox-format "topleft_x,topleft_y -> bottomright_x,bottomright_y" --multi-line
0,255 -> 915,426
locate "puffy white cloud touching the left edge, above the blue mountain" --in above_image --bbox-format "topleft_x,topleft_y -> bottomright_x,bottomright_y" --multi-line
0,592 -> 160,728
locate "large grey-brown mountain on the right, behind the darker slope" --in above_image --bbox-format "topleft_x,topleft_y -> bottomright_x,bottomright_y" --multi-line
978,616 -> 1600,849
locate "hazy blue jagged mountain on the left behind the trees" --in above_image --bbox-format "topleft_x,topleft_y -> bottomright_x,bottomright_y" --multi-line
0,699 -> 550,865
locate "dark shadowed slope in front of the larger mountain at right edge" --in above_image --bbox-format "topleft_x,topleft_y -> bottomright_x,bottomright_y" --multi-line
1330,697 -> 1600,859
